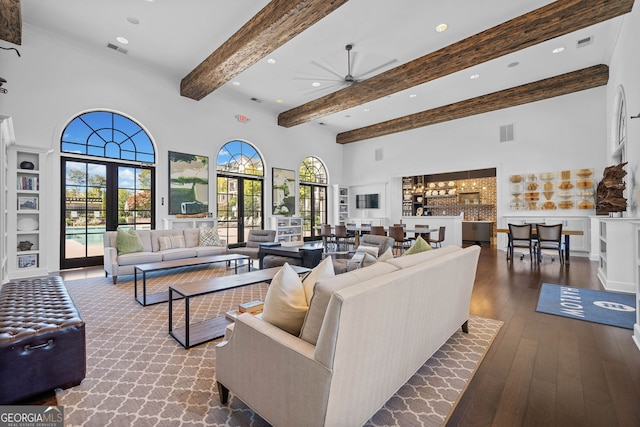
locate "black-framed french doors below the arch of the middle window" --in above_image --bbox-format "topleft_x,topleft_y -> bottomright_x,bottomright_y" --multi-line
217,175 -> 263,243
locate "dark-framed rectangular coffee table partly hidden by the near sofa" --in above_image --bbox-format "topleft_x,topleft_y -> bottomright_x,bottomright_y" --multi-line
169,265 -> 311,349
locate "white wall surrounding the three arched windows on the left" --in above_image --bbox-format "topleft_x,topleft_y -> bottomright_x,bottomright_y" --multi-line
0,26 -> 343,271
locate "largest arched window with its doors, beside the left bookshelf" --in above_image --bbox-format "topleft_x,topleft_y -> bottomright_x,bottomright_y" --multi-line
60,111 -> 156,268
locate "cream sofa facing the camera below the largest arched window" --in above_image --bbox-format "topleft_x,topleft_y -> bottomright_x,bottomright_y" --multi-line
103,228 -> 228,285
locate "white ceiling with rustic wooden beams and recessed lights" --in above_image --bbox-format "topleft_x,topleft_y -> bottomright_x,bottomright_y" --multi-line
5,0 -> 634,144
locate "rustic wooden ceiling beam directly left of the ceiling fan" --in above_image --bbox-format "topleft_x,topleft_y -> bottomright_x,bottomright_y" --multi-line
180,0 -> 348,101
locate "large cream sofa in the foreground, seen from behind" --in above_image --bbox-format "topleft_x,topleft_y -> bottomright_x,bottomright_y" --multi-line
216,246 -> 480,427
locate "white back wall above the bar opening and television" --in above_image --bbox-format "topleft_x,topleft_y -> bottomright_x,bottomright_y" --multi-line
344,87 -> 607,222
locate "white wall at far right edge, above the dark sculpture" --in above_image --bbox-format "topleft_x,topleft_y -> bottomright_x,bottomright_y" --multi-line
606,5 -> 640,217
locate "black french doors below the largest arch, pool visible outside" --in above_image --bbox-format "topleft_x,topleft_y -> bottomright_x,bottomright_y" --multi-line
60,157 -> 155,269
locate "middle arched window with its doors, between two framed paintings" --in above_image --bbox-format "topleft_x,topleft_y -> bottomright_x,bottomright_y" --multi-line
216,140 -> 264,243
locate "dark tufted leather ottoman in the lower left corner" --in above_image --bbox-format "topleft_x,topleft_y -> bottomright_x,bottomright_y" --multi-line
0,276 -> 86,405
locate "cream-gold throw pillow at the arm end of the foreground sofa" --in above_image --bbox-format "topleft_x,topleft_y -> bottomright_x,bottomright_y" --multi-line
262,263 -> 309,336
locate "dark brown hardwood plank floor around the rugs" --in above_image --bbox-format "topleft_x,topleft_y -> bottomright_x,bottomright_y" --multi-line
15,246 -> 640,427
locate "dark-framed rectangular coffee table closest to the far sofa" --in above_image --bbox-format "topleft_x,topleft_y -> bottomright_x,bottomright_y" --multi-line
133,254 -> 251,307
